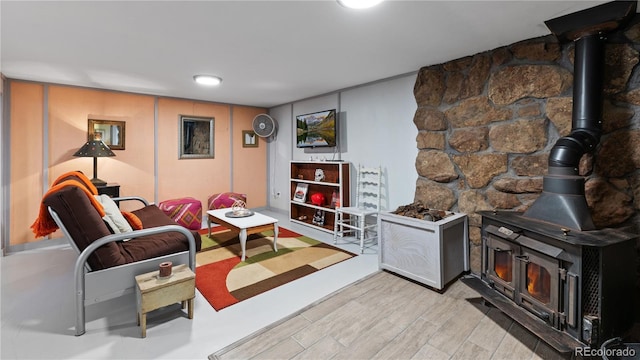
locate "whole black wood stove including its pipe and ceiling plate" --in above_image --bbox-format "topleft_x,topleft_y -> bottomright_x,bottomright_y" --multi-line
464,1 -> 638,353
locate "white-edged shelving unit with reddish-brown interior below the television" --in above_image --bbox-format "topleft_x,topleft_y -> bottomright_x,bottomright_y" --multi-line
289,161 -> 351,233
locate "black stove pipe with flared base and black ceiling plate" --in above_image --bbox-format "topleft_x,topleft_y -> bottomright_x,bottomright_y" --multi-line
524,1 -> 637,230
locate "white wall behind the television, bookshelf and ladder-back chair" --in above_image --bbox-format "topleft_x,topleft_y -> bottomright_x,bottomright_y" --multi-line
269,74 -> 418,212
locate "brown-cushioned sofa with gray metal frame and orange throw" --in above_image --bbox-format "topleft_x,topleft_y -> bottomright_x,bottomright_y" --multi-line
32,172 -> 201,335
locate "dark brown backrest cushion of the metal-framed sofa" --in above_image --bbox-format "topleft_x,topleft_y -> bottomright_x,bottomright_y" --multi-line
43,186 -> 126,270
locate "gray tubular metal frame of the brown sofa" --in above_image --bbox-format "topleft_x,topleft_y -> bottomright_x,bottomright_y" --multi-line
48,196 -> 196,336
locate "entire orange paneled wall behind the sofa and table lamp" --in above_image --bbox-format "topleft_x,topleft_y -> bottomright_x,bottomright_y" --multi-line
9,80 -> 267,245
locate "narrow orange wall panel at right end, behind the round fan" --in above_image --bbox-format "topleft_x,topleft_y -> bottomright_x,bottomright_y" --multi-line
232,106 -> 268,208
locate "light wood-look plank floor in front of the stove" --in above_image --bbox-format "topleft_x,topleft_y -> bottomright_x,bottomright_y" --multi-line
210,272 -> 562,360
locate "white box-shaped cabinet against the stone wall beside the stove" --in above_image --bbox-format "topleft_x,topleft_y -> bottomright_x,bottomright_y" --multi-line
378,213 -> 469,291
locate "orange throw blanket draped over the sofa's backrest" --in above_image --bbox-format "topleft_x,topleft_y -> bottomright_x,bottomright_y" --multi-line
31,179 -> 105,237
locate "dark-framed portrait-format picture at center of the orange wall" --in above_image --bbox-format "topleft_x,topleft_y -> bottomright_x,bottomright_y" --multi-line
178,115 -> 214,159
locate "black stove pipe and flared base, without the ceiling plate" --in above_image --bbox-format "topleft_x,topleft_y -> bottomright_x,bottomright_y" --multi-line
524,34 -> 605,230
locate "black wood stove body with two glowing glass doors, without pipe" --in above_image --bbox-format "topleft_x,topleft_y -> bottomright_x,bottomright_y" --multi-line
463,211 -> 638,352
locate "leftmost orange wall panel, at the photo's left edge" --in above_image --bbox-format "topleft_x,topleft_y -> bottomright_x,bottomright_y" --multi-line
9,83 -> 44,245
